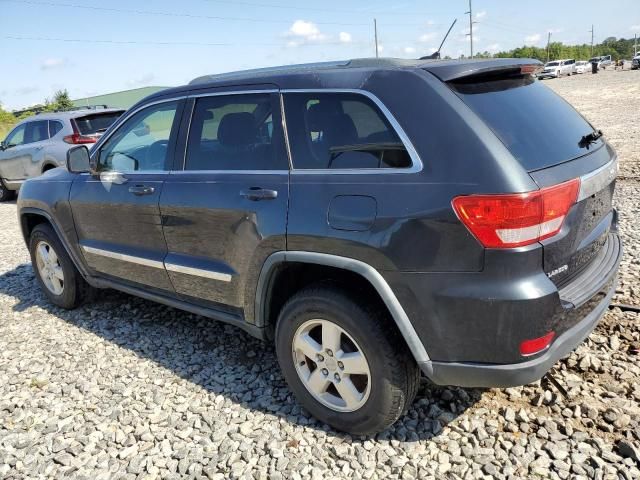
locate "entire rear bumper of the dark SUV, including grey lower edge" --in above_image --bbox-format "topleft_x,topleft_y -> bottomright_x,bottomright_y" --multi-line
389,231 -> 622,387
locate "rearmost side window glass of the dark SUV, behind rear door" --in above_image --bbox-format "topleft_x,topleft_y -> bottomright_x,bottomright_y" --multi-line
285,92 -> 411,170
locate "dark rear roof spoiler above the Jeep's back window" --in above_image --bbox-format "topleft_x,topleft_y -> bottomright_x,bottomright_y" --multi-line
422,58 -> 543,82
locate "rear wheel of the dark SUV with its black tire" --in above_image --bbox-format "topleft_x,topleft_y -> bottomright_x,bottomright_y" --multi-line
275,285 -> 420,435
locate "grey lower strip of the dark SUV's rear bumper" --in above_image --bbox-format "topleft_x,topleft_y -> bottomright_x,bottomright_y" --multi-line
420,282 -> 615,387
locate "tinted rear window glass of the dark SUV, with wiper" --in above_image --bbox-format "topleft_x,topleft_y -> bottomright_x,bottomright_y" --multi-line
450,75 -> 602,171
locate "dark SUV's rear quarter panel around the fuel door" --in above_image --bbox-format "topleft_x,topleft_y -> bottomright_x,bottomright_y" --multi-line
287,71 -> 537,272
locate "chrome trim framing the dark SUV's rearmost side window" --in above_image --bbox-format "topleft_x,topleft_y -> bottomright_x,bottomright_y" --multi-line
280,88 -> 424,175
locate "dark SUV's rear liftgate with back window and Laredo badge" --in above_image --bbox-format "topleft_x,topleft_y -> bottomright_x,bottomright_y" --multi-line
449,74 -> 617,285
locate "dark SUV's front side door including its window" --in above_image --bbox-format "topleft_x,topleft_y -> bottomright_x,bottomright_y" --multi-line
70,100 -> 182,292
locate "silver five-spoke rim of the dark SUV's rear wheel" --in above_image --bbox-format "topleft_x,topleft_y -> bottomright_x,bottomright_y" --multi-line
292,319 -> 371,412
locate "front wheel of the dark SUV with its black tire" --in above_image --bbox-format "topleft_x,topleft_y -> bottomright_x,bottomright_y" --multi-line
29,224 -> 90,310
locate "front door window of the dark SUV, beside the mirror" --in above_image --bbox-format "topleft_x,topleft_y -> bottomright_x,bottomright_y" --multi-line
98,101 -> 178,172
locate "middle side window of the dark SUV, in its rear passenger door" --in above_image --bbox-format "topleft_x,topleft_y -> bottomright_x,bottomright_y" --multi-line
185,93 -> 288,170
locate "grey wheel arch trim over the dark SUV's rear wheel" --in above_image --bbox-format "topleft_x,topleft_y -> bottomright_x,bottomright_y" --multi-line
253,251 -> 431,373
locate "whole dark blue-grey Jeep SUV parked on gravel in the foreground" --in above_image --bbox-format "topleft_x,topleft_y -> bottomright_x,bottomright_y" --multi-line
18,59 -> 622,435
